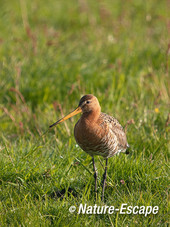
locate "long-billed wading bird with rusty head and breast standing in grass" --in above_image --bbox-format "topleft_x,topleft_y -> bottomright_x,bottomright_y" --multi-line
49,94 -> 129,201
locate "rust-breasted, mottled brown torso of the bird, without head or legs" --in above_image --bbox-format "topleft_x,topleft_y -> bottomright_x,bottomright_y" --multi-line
74,113 -> 127,158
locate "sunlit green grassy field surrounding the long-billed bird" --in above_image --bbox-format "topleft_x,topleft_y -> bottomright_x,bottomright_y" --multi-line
0,0 -> 170,227
